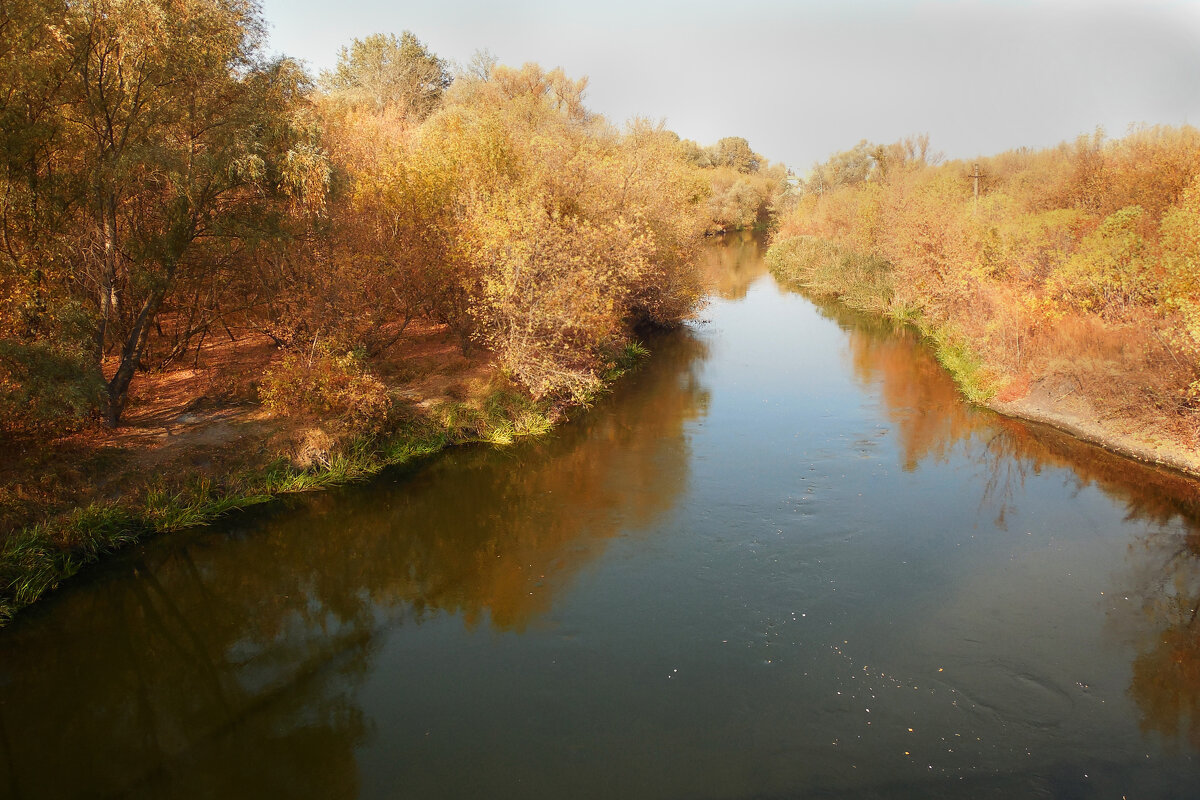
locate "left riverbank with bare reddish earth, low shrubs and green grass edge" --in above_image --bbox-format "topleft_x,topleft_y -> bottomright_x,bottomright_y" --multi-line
0,326 -> 647,625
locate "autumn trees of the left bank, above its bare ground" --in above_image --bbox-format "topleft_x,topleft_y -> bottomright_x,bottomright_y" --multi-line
0,0 -> 781,432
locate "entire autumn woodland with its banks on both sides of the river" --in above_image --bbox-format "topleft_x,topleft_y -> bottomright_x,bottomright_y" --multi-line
0,0 -> 1200,618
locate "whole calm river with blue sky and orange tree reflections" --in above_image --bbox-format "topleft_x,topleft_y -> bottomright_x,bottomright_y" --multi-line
0,236 -> 1200,800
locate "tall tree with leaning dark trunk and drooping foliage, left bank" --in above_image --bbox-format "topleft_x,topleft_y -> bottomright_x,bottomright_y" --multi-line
66,0 -> 302,425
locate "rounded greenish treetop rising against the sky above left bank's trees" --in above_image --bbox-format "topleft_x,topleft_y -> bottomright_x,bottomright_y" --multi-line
322,31 -> 451,120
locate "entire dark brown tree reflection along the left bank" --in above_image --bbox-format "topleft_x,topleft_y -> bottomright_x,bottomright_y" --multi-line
0,331 -> 708,798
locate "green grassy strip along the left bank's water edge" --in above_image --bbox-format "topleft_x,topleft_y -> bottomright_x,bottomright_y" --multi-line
0,343 -> 648,625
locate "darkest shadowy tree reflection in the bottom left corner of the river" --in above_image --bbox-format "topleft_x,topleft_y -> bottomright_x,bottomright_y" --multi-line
0,541 -> 371,798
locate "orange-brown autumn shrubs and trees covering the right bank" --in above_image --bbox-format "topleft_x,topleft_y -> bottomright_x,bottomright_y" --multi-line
772,127 -> 1200,469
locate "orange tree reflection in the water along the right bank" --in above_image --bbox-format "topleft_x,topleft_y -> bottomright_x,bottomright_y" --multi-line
818,292 -> 1200,751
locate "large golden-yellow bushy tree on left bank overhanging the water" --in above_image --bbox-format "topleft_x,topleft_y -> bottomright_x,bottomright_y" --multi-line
421,64 -> 707,398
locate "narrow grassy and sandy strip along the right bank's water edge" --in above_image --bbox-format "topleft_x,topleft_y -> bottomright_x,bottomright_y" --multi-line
767,236 -> 1200,477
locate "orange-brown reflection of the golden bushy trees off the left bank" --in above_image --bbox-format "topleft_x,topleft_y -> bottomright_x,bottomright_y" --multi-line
302,332 -> 708,631
